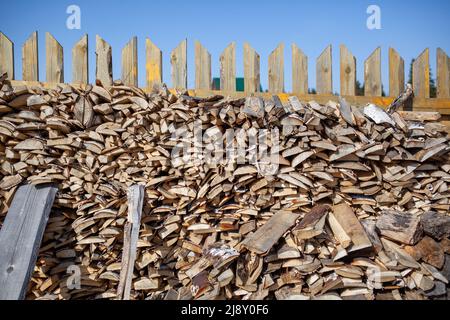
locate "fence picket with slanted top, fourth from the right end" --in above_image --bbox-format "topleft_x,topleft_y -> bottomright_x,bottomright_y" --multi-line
364,47 -> 383,97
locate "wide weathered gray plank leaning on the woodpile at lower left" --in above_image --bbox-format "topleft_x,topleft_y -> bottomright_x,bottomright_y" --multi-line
0,185 -> 57,300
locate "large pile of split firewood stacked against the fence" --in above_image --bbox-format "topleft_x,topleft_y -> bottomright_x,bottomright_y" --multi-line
0,72 -> 450,300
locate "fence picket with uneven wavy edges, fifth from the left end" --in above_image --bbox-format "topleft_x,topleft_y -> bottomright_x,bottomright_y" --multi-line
95,35 -> 113,86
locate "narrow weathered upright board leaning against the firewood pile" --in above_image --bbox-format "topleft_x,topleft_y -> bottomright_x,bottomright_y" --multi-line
117,185 -> 145,300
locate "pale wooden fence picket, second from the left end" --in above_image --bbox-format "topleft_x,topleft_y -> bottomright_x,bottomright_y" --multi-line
22,31 -> 39,81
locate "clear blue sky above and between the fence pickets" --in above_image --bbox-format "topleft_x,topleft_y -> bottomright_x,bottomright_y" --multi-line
0,0 -> 450,92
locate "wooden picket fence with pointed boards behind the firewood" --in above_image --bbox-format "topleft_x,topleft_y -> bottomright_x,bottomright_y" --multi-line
0,32 -> 450,118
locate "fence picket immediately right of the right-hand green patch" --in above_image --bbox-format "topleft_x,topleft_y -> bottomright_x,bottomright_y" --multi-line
244,42 -> 261,93
